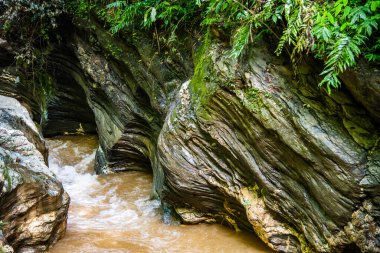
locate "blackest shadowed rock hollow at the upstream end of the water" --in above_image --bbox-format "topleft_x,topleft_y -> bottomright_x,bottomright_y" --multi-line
42,47 -> 96,137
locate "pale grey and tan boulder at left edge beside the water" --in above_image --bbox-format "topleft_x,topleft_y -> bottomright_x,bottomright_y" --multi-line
0,96 -> 69,252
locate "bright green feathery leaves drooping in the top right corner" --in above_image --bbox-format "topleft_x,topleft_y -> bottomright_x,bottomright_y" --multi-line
312,0 -> 380,93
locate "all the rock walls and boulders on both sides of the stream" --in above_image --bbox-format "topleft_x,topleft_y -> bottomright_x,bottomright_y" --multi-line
0,1 -> 380,253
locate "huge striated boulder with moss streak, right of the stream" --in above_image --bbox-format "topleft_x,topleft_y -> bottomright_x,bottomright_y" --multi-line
158,42 -> 380,252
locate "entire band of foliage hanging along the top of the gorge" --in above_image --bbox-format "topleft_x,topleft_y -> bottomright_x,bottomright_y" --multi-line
0,0 -> 380,93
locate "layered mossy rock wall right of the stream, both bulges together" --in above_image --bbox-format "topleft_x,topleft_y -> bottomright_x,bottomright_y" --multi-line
3,13 -> 380,252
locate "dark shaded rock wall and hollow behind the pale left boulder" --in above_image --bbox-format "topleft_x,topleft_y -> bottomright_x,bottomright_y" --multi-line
0,40 -> 96,137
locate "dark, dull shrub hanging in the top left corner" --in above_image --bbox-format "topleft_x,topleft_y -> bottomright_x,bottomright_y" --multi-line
0,0 -> 66,70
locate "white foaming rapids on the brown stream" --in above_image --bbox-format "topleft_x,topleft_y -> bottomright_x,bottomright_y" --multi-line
49,140 -> 160,236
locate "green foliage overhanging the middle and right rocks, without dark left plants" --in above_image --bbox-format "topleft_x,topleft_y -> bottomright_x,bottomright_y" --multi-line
99,0 -> 380,93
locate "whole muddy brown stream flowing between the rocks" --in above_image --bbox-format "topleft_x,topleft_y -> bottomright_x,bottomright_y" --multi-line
48,136 -> 272,253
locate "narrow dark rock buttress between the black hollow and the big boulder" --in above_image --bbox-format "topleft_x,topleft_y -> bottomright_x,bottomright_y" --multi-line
67,20 -> 192,178
